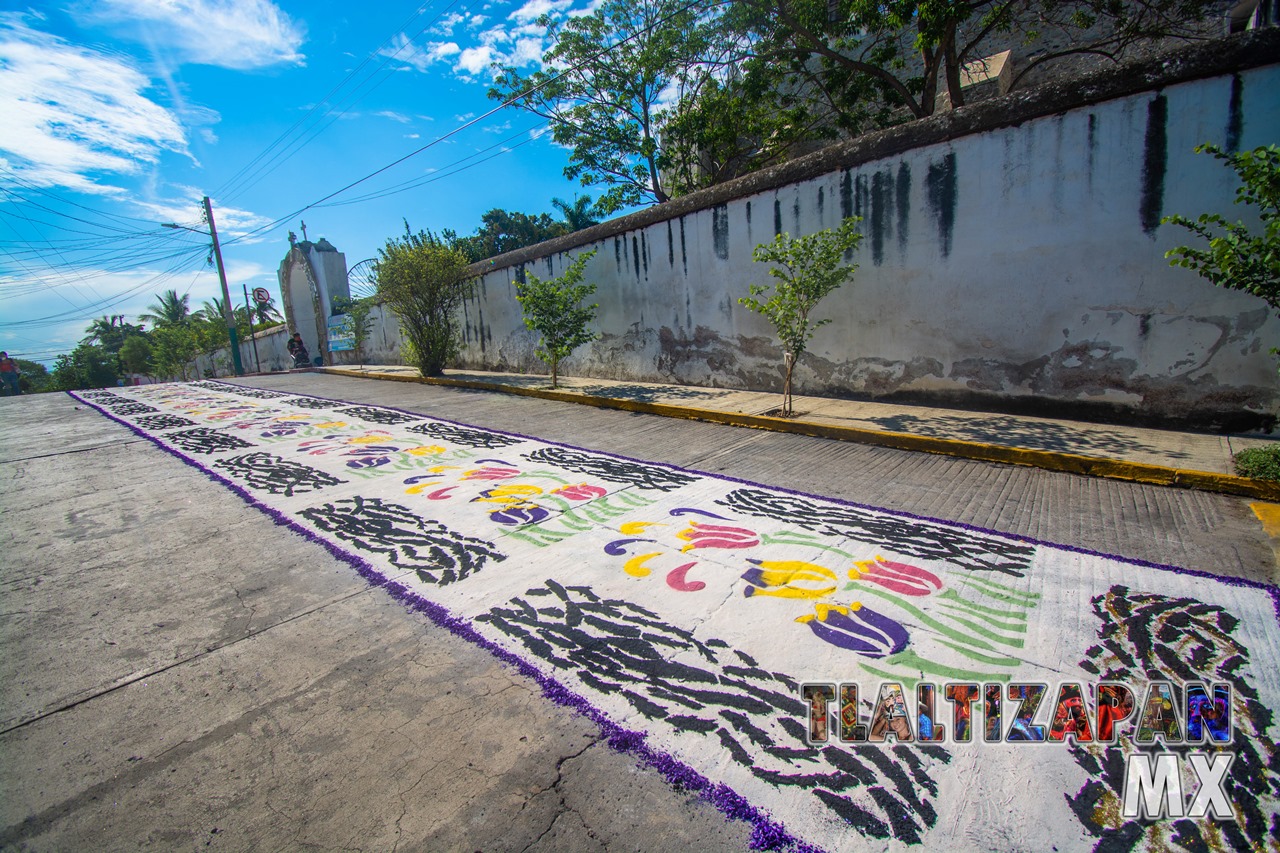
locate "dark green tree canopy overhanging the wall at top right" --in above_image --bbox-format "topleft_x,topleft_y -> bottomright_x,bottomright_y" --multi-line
731,0 -> 1220,133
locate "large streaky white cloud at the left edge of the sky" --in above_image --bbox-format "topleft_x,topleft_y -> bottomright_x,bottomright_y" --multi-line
0,17 -> 189,195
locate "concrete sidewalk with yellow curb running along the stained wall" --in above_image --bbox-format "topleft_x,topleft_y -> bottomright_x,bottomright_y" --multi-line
324,365 -> 1280,501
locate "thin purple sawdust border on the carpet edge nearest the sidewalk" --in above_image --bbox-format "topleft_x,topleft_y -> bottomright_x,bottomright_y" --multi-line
205,379 -> 1280,624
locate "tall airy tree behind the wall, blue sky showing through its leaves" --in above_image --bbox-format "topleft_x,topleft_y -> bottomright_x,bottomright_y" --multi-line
489,0 -> 719,215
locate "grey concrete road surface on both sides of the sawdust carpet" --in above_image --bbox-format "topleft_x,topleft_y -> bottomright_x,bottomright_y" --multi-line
0,374 -> 1276,850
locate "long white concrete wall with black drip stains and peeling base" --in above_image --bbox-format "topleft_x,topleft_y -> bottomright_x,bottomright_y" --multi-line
450,31 -> 1280,429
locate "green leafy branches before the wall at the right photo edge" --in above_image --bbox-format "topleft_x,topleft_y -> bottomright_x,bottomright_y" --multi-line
1161,143 -> 1280,311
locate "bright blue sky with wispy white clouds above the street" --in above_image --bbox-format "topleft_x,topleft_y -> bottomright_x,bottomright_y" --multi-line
0,0 -> 609,364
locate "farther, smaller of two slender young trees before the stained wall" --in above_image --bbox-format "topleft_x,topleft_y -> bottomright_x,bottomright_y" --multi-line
516,250 -> 599,388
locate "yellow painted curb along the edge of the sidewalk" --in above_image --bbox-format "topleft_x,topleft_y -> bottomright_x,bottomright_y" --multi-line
325,368 -> 1280,501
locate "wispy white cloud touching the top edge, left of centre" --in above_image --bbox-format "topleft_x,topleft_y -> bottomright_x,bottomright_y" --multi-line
88,0 -> 306,70
